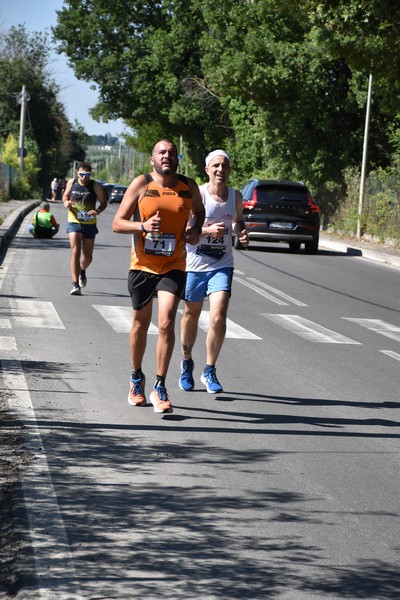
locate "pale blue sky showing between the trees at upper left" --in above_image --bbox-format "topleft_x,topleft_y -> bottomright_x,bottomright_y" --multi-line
0,0 -> 125,136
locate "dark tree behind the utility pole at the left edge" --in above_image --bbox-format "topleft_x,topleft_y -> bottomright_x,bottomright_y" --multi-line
0,25 -> 87,195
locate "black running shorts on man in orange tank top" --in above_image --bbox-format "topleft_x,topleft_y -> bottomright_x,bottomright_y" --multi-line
128,269 -> 186,310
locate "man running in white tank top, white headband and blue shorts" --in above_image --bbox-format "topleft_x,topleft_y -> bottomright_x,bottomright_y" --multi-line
179,150 -> 249,394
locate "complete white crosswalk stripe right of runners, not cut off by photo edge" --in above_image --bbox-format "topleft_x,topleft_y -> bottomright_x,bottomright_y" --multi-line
262,314 -> 361,345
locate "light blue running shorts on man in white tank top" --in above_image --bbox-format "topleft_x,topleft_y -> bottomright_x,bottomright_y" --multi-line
184,267 -> 233,302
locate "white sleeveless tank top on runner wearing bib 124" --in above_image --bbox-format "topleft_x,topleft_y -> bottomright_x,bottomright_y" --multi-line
186,183 -> 236,271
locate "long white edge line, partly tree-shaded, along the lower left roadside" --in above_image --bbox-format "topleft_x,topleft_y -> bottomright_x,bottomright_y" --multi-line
0,360 -> 81,600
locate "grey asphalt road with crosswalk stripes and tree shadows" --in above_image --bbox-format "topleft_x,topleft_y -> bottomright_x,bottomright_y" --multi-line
0,205 -> 400,600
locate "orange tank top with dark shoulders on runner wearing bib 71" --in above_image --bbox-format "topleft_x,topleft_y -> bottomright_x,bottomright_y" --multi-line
130,174 -> 192,274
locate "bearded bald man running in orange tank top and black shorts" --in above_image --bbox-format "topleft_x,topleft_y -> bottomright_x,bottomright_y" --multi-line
112,139 -> 204,413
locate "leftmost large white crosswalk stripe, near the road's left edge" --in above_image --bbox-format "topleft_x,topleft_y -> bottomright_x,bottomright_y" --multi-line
9,298 -> 65,329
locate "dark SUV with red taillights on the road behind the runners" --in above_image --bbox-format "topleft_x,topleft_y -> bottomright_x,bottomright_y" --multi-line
234,179 -> 320,254
